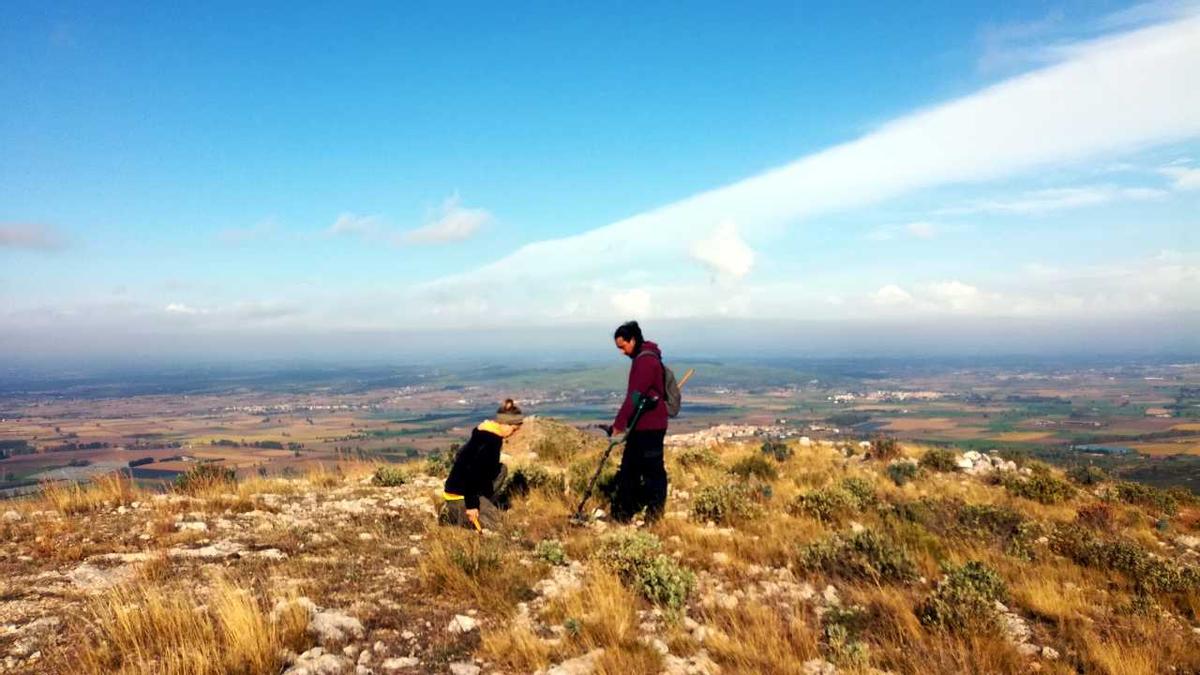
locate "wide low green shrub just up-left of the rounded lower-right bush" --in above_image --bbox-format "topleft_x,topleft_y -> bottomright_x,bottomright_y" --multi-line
797,530 -> 917,583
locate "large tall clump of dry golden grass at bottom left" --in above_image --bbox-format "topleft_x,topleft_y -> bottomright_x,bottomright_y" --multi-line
70,577 -> 307,675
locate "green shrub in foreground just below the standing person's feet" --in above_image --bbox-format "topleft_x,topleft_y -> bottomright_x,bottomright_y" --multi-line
596,532 -> 696,610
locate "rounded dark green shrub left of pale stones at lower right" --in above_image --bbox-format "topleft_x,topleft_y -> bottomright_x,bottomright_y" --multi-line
917,561 -> 1008,633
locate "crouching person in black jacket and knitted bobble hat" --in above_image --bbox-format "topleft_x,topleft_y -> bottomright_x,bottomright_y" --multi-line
439,399 -> 524,530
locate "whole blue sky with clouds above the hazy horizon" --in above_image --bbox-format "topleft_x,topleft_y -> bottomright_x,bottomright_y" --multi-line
0,2 -> 1200,352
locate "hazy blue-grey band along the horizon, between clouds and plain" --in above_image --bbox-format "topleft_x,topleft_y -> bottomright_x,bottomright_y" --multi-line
0,313 -> 1200,366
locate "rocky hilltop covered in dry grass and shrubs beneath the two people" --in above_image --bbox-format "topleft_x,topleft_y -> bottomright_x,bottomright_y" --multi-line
0,419 -> 1200,675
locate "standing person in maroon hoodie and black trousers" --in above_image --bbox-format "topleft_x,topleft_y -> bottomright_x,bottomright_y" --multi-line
610,321 -> 667,522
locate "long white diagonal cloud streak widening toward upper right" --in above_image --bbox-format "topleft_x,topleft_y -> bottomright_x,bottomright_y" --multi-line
413,14 -> 1200,321
